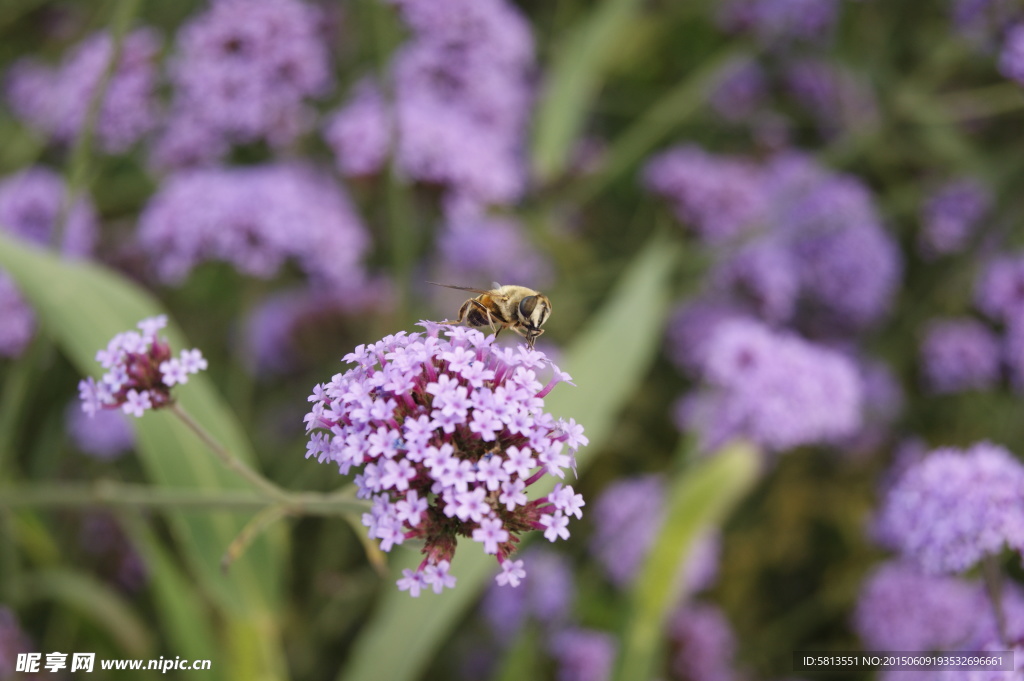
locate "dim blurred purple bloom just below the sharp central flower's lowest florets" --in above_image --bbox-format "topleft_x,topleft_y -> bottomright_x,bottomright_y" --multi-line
480,547 -> 575,643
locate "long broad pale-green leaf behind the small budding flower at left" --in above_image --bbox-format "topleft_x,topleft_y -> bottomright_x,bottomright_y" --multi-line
0,228 -> 284,676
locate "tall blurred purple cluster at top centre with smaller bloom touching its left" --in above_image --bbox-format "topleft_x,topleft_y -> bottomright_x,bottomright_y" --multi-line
326,0 -> 534,204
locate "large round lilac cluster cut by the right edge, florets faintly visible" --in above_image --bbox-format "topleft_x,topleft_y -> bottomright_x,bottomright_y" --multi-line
878,442 -> 1024,574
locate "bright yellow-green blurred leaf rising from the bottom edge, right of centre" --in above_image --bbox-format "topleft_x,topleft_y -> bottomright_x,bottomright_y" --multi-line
615,442 -> 760,681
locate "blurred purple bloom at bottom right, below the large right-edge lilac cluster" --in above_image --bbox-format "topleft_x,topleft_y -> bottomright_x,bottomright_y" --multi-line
854,561 -> 986,652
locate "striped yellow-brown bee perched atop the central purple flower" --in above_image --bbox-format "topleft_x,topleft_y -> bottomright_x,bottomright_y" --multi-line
427,282 -> 551,348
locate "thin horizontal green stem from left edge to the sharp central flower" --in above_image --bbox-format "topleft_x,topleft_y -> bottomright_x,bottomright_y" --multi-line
0,480 -> 368,515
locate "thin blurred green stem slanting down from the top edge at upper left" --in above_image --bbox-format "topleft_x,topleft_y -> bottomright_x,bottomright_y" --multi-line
50,0 -> 139,250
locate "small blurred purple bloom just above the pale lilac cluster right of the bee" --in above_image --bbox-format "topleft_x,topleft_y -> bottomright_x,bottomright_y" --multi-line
714,240 -> 800,323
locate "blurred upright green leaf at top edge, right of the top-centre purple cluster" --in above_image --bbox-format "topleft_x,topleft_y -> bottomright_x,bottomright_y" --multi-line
534,0 -> 640,182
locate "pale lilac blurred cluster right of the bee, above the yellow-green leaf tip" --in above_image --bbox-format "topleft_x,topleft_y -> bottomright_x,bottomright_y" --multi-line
681,320 -> 863,451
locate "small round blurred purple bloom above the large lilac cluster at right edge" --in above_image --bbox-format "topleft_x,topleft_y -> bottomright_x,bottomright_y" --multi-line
921,318 -> 999,393
